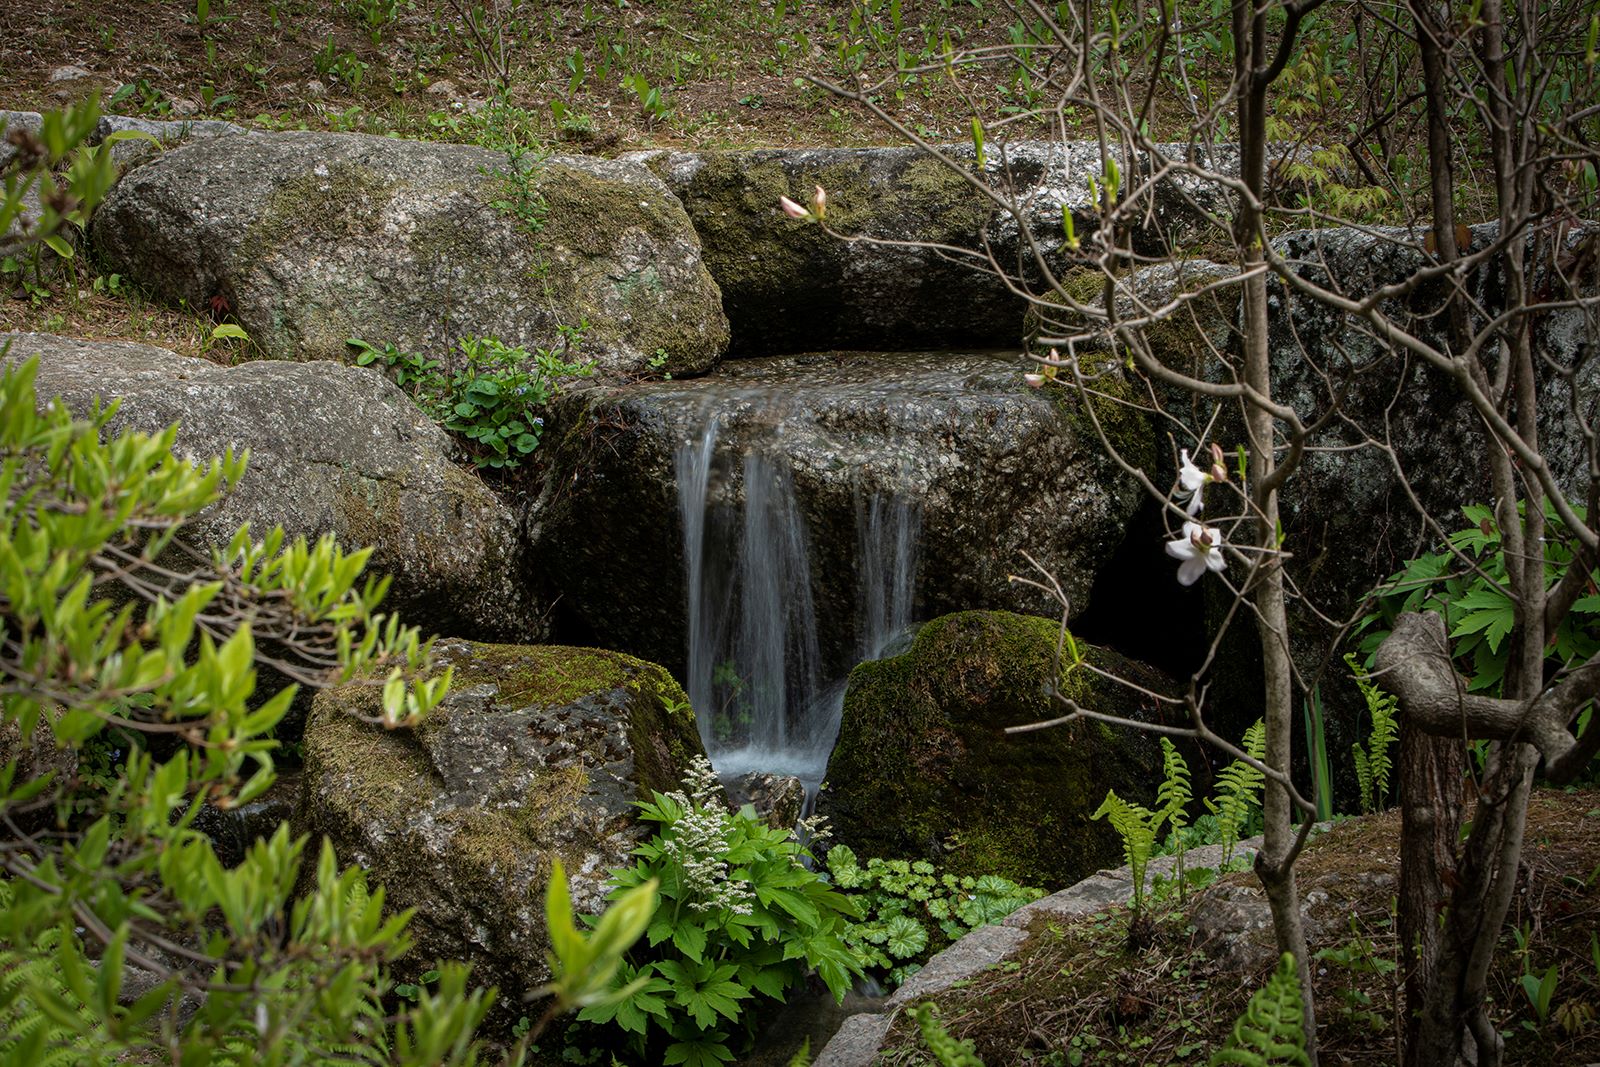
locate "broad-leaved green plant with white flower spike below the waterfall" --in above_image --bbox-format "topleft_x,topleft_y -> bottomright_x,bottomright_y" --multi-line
578,758 -> 861,1067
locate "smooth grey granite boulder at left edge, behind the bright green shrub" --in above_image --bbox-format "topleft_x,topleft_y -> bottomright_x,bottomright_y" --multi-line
0,334 -> 544,640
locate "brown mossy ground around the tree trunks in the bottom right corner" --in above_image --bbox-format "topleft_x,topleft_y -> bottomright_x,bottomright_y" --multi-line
883,790 -> 1600,1067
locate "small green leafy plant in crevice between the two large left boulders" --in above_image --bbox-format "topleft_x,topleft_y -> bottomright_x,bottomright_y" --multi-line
347,328 -> 594,470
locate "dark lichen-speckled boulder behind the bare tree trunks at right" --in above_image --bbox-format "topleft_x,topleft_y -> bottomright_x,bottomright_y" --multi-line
1269,224 -> 1600,617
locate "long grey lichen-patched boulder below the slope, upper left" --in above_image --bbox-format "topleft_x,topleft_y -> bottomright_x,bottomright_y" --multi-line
91,133 -> 728,373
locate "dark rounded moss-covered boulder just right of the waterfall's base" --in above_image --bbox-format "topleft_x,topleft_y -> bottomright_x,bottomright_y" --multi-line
821,611 -> 1170,888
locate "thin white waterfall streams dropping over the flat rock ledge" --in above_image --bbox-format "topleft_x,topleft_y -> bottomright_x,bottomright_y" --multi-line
674,414 -> 920,793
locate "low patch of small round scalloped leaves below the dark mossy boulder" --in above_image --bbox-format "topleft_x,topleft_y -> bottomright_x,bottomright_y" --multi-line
827,845 -> 1045,987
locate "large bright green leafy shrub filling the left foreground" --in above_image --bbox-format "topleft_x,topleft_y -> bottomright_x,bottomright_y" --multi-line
0,362 -> 521,1065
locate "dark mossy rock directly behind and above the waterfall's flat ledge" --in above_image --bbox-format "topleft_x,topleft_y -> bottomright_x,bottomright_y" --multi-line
646,149 -> 1022,355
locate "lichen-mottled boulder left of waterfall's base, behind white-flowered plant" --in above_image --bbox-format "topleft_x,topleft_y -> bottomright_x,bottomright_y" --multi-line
304,641 -> 702,1005
